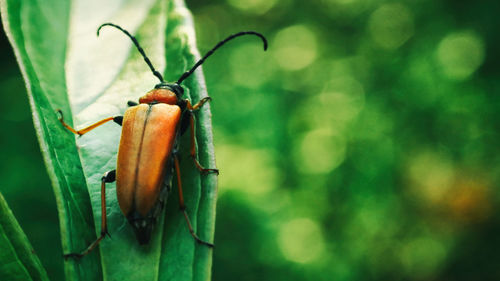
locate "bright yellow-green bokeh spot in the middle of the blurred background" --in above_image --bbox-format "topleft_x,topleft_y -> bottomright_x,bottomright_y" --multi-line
295,128 -> 346,174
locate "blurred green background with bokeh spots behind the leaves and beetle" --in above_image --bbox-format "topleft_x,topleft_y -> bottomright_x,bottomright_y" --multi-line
0,0 -> 500,281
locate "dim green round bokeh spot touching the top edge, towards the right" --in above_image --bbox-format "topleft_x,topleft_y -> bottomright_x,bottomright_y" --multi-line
368,4 -> 413,49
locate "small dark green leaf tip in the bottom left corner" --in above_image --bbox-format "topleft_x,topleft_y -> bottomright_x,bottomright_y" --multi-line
0,191 -> 49,281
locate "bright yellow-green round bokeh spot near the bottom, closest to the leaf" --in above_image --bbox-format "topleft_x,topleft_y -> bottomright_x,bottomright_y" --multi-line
278,218 -> 325,263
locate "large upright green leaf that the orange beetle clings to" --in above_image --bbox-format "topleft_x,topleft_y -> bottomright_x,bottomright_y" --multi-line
2,0 -> 217,281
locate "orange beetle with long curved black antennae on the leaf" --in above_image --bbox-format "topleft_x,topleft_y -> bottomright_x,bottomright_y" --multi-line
57,23 -> 267,258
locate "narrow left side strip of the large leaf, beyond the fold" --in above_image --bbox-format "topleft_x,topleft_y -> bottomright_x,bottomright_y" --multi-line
1,0 -> 102,280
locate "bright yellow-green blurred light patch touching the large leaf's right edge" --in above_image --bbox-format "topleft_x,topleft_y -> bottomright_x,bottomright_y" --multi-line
216,144 -> 278,196
